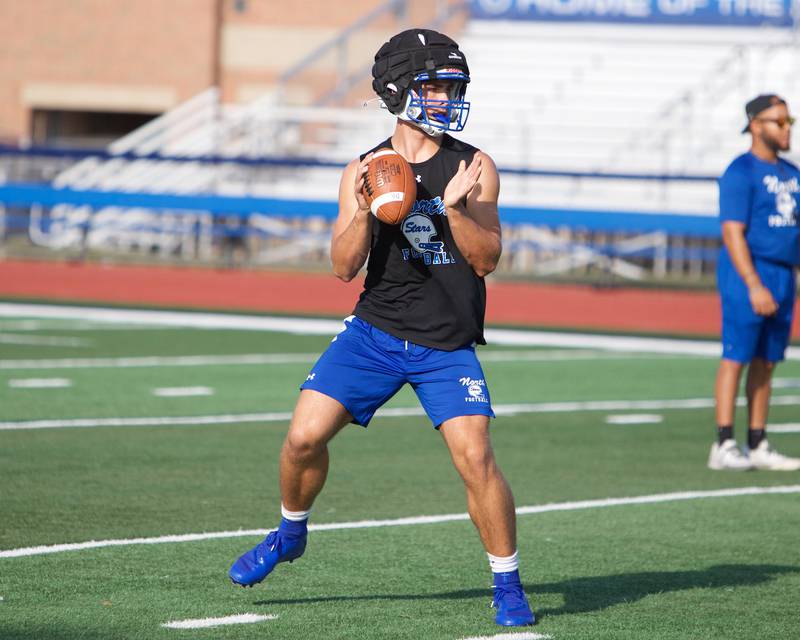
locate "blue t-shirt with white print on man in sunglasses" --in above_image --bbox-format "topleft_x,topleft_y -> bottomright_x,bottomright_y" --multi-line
719,152 -> 800,265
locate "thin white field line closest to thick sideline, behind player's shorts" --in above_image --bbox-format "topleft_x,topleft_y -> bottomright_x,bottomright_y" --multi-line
0,349 -> 692,370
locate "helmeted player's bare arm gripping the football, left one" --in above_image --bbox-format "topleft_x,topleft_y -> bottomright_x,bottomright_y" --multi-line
331,153 -> 373,282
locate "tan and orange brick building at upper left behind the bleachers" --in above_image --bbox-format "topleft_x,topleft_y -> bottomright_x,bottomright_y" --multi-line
0,0 -> 462,145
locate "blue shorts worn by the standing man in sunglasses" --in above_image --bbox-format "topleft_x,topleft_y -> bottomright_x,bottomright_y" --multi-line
717,251 -> 796,364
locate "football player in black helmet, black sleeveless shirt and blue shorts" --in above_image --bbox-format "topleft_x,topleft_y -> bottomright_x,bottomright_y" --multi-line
230,29 -> 534,626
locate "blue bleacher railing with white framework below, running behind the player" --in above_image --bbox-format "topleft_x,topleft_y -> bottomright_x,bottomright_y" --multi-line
0,146 -> 719,280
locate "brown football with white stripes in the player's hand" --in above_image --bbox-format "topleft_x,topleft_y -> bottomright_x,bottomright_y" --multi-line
362,148 -> 417,224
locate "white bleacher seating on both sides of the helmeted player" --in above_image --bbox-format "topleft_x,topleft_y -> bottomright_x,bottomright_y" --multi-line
45,20 -> 800,244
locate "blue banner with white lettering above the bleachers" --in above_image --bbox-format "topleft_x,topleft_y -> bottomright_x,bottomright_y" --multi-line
470,0 -> 794,27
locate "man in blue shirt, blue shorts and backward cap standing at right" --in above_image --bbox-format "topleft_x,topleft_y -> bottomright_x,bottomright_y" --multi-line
708,95 -> 800,471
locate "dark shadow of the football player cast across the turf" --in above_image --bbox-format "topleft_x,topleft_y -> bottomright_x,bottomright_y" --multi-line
253,564 -> 800,618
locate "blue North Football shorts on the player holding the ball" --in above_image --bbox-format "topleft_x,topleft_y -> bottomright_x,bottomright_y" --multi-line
300,316 -> 494,429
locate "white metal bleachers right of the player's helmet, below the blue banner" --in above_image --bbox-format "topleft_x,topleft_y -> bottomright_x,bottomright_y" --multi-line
461,21 -> 797,213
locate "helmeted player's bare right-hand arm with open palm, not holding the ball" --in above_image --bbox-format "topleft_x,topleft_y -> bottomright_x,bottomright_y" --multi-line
444,151 -> 502,277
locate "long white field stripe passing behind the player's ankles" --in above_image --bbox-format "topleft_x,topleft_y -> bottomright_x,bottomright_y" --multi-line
0,484 -> 800,558
